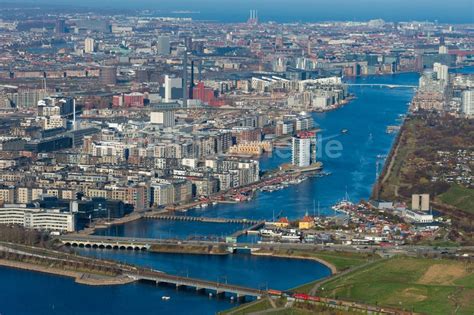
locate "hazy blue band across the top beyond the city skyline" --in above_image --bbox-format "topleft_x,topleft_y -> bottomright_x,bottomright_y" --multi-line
0,0 -> 474,23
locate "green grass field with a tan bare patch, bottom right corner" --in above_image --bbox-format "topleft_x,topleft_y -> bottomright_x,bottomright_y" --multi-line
318,258 -> 474,314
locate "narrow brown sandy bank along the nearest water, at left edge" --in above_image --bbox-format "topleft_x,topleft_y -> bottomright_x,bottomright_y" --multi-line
0,259 -> 135,286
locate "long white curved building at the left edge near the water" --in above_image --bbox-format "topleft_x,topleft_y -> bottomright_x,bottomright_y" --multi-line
0,204 -> 76,232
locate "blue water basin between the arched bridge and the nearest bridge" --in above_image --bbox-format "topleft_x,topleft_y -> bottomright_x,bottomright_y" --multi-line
76,249 -> 330,290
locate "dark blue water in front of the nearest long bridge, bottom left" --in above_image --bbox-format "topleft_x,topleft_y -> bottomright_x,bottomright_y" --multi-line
0,268 -> 234,315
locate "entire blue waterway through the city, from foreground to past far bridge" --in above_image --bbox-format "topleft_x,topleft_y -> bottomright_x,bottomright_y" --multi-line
0,73 -> 418,314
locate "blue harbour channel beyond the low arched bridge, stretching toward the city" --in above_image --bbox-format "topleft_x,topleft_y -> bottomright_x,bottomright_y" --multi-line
92,73 -> 419,241
